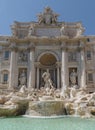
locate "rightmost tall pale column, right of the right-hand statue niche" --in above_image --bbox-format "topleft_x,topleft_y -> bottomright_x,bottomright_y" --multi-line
81,49 -> 86,87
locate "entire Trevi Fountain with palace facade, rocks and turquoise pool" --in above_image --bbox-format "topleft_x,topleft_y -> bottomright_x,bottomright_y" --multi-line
0,7 -> 95,130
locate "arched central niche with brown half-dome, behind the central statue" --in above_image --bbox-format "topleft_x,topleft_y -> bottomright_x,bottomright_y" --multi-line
39,53 -> 57,87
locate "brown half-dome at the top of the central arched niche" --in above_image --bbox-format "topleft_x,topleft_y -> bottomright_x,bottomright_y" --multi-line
40,53 -> 57,66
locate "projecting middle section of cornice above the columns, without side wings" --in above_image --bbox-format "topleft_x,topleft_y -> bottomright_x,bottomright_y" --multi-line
9,36 -> 87,44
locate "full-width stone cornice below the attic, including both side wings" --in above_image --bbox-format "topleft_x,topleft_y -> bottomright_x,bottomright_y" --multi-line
0,36 -> 95,46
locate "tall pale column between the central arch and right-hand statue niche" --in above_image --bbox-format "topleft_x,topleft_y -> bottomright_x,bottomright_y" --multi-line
61,48 -> 67,89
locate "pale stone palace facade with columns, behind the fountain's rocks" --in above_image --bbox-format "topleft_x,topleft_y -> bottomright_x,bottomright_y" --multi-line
0,7 -> 95,92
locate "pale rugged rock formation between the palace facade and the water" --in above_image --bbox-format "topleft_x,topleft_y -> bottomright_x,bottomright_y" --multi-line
0,87 -> 95,118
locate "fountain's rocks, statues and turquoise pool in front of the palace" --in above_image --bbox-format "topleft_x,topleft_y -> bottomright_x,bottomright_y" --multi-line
0,71 -> 95,130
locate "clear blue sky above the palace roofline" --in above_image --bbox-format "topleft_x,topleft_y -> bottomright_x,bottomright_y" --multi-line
0,0 -> 95,35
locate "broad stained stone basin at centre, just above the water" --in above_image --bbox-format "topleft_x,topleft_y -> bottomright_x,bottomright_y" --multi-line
26,100 -> 66,116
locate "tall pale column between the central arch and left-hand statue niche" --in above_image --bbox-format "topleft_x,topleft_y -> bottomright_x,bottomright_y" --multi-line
29,47 -> 35,88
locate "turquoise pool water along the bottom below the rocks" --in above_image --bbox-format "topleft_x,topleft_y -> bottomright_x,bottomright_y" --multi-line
0,117 -> 95,130
